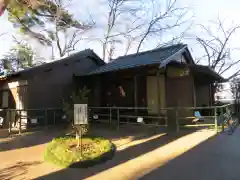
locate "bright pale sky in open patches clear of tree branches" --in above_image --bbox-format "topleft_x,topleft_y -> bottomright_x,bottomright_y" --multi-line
0,0 -> 240,76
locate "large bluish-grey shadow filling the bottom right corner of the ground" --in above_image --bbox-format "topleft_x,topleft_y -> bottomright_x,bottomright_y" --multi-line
141,128 -> 240,180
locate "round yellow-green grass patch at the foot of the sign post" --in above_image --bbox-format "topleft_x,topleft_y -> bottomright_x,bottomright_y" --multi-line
44,137 -> 113,167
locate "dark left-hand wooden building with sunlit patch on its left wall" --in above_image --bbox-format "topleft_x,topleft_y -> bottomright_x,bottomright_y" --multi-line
0,49 -> 105,109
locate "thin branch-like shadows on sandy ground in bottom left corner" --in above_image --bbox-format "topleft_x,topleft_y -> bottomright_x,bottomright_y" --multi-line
0,161 -> 42,180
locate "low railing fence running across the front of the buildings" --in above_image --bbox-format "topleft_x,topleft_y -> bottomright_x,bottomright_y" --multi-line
0,104 -> 235,133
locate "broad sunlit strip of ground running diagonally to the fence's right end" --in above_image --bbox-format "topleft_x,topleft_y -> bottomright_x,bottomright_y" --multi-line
88,131 -> 215,180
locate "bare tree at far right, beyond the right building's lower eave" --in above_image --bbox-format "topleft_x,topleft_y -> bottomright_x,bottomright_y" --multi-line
196,20 -> 240,80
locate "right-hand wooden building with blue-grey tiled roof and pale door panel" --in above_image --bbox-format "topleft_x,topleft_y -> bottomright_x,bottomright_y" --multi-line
75,44 -> 224,127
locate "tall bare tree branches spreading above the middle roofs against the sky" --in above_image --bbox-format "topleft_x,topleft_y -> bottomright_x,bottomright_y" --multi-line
94,0 -> 188,60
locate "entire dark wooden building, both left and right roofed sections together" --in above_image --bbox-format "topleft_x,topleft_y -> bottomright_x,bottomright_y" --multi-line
0,44 -> 224,129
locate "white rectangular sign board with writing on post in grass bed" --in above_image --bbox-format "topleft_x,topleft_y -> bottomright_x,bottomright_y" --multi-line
74,104 -> 88,125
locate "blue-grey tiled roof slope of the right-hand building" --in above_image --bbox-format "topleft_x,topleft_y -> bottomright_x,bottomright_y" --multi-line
87,44 -> 187,75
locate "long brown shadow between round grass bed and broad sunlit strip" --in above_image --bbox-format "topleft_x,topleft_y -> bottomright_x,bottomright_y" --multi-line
36,124 -> 199,180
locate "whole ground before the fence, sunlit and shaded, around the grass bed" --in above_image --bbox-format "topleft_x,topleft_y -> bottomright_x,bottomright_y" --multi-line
0,126 -> 240,180
